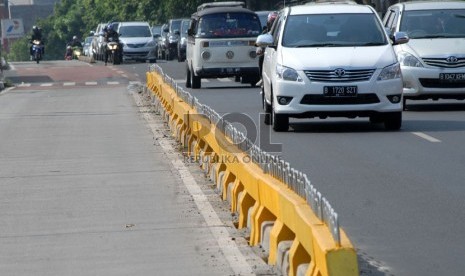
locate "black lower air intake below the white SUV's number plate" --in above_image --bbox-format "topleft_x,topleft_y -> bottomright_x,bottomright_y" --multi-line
300,93 -> 379,105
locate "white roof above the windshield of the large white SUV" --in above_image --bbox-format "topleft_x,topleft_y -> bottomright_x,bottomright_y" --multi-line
288,1 -> 373,15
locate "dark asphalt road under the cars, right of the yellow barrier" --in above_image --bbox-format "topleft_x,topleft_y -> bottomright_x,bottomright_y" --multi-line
129,58 -> 465,276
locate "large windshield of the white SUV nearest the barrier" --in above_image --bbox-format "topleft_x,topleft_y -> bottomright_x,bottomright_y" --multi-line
282,13 -> 388,48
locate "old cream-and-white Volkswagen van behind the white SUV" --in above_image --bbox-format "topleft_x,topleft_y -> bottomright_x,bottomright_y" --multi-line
186,2 -> 261,88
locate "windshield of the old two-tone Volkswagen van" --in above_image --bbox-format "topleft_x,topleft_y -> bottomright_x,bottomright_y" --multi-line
197,12 -> 261,38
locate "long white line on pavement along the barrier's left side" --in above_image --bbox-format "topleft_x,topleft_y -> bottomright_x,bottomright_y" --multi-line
133,93 -> 254,275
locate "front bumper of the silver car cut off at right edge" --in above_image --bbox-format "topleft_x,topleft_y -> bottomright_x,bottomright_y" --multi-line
401,66 -> 465,99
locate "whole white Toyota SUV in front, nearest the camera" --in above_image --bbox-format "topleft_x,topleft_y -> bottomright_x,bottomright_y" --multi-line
257,2 -> 408,131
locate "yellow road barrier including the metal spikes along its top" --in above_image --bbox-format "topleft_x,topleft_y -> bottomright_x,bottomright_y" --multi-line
146,64 -> 359,276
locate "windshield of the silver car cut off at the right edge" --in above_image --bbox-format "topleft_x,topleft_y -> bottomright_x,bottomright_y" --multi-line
400,9 -> 465,39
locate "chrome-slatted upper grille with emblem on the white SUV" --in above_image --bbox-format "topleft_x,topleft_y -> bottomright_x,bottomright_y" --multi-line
304,69 -> 375,82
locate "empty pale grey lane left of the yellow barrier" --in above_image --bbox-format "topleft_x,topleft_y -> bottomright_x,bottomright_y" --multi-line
0,61 -> 274,276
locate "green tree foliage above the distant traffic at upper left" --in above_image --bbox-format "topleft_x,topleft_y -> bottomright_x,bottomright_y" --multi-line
8,0 -> 282,60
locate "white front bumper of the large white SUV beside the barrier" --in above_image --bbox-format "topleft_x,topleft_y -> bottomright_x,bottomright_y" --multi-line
273,76 -> 402,118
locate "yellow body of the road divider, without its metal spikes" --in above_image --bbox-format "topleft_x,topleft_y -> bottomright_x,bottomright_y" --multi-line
147,69 -> 359,276
